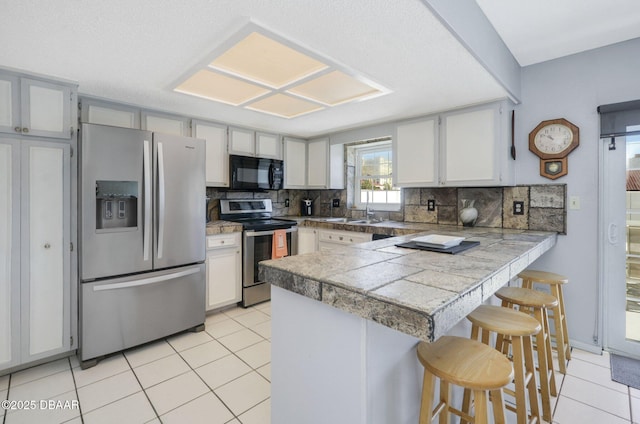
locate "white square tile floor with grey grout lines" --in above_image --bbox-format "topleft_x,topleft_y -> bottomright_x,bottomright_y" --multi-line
0,303 -> 640,424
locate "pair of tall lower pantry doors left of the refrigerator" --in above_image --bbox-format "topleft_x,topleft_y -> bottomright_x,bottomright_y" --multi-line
0,139 -> 73,373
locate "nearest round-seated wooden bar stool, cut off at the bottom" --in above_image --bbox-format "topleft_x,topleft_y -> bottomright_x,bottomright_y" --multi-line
418,336 -> 513,424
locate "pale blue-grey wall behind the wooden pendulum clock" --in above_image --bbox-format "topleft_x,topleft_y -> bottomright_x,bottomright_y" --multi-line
515,39 -> 640,346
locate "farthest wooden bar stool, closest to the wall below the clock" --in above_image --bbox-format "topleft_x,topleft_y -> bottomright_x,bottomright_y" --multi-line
518,270 -> 571,374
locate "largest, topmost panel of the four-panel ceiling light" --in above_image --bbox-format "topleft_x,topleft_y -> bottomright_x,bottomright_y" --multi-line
209,32 -> 328,88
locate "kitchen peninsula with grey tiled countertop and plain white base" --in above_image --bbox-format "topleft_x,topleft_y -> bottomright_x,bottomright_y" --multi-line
260,225 -> 556,424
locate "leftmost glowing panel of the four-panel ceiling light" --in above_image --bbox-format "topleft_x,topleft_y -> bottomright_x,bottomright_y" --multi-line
175,69 -> 270,106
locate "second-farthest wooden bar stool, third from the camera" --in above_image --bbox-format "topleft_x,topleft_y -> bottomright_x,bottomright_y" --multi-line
496,287 -> 558,422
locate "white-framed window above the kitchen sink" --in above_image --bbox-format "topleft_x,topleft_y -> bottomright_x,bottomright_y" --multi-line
354,140 -> 400,210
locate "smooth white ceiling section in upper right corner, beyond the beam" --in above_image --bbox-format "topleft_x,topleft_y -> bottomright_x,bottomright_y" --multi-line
476,0 -> 640,66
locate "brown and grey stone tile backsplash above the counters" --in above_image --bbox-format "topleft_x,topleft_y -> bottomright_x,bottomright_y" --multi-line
207,184 -> 567,234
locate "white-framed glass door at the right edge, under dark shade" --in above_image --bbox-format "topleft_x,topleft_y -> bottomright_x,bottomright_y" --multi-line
600,132 -> 640,358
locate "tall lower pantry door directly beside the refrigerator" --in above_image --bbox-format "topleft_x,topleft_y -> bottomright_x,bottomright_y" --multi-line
21,142 -> 71,362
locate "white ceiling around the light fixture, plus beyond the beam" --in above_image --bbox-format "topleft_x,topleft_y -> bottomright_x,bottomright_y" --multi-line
0,0 -> 640,137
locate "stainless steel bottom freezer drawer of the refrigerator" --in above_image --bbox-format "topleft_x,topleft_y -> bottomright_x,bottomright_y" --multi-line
79,264 -> 206,361
